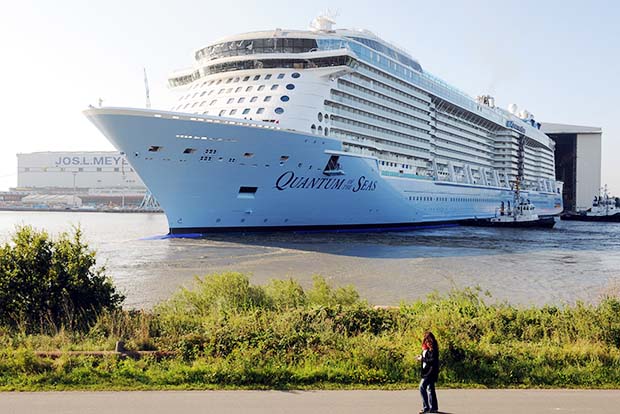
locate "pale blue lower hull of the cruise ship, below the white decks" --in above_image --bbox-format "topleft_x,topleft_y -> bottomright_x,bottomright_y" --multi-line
86,108 -> 562,234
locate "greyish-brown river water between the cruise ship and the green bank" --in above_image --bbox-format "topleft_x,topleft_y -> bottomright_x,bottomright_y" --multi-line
0,212 -> 620,308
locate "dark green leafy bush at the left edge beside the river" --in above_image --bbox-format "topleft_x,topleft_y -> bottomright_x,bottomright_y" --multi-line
0,226 -> 124,332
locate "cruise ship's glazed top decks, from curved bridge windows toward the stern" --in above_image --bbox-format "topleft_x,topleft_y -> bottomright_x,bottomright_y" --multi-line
169,25 -> 553,148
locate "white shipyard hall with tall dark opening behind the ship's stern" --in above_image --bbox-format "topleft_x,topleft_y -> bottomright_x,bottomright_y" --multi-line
541,123 -> 603,211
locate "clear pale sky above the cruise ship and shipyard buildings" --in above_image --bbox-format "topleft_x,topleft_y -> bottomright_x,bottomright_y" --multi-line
0,0 -> 620,194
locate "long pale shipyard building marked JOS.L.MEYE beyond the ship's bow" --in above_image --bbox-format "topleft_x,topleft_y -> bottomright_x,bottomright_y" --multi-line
12,151 -> 146,207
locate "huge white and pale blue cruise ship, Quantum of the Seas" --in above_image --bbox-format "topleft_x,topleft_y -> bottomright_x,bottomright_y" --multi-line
85,16 -> 562,234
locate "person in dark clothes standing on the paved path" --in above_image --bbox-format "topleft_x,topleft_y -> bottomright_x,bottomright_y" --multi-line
418,332 -> 439,413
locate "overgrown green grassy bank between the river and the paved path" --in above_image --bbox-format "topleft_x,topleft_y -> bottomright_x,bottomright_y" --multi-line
0,273 -> 620,390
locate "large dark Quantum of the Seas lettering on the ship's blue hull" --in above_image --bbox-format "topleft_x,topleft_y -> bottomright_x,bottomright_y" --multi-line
275,171 -> 377,193
